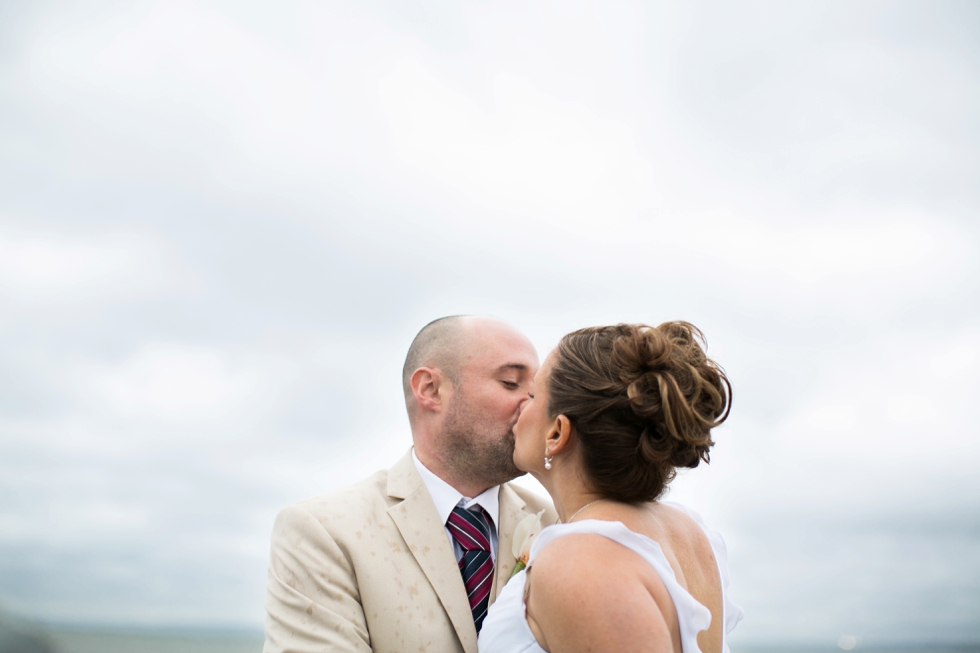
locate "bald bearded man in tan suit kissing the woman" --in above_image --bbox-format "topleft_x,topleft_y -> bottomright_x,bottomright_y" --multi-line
264,316 -> 557,653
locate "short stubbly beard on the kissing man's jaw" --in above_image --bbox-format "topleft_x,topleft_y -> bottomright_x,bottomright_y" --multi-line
443,391 -> 524,488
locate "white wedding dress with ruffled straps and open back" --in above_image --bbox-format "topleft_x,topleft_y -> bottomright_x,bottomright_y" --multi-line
479,502 -> 742,653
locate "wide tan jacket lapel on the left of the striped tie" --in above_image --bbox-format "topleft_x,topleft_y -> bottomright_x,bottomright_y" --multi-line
388,452 -> 476,653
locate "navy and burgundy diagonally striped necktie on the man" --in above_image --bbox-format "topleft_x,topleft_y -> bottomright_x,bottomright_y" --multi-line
446,506 -> 493,633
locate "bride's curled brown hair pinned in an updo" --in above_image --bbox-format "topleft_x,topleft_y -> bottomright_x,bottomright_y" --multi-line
548,322 -> 731,503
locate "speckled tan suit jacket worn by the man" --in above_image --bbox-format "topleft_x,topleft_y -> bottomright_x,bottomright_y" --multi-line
264,452 -> 557,653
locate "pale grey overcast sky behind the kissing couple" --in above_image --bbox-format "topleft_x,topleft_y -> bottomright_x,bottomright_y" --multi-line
0,1 -> 980,645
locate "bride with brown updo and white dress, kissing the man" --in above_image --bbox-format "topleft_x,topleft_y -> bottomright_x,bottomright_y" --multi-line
479,322 -> 742,653
